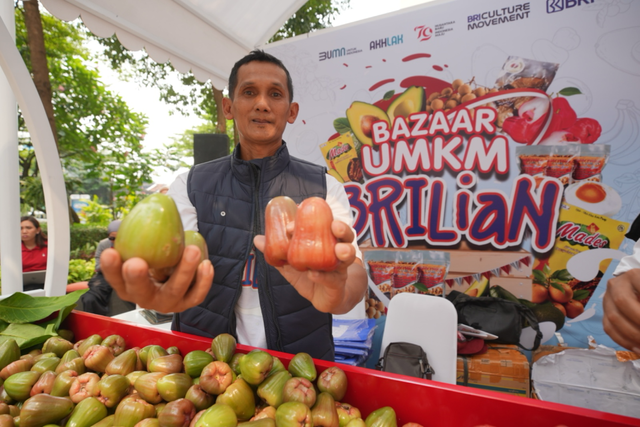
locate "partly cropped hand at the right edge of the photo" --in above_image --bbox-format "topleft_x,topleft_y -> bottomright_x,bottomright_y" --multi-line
602,268 -> 640,354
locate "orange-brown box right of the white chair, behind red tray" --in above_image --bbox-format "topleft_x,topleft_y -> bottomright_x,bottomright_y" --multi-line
456,344 -> 530,397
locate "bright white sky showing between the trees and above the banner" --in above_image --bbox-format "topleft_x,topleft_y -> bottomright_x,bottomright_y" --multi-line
101,0 -> 432,185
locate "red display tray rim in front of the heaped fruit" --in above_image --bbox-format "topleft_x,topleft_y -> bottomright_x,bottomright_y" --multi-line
64,311 -> 640,427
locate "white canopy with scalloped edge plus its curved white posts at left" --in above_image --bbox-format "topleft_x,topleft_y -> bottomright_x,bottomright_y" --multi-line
0,0 -> 306,297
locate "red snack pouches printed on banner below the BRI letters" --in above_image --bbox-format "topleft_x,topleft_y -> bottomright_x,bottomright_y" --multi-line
364,249 -> 449,319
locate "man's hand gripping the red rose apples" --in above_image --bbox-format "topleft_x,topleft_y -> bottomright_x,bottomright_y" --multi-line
253,220 -> 367,314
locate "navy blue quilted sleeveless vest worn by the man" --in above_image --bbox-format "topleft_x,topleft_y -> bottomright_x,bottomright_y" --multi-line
172,142 -> 334,361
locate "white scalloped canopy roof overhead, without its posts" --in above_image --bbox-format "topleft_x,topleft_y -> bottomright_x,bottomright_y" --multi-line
40,0 -> 306,89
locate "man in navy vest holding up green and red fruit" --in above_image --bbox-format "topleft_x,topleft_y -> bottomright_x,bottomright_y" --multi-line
101,51 -> 367,360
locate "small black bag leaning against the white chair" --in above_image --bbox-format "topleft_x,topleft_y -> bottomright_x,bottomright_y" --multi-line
376,342 -> 435,380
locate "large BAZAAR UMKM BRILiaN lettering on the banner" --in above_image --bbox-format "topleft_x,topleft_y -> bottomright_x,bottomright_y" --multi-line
345,107 -> 563,253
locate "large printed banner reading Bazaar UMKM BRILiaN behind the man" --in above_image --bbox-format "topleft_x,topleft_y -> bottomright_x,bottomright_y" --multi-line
265,0 -> 640,347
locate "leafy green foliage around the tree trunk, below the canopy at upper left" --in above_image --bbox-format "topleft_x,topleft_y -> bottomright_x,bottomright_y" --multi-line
16,6 -> 175,219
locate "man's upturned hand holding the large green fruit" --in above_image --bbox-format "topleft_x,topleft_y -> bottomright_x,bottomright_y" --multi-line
100,245 -> 213,313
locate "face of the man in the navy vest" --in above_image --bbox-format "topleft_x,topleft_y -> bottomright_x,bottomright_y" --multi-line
223,61 -> 298,147
